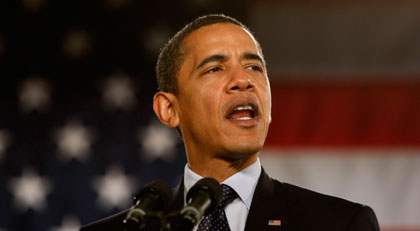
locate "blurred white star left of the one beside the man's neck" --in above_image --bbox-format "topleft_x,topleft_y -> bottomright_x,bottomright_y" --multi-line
56,120 -> 93,162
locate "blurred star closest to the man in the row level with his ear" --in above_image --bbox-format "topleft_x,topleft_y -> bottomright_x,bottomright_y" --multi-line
103,73 -> 136,109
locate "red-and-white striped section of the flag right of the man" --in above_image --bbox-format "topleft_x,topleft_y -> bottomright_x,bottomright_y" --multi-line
252,0 -> 420,231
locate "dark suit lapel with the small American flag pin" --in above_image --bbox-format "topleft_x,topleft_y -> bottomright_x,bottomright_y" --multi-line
245,169 -> 293,231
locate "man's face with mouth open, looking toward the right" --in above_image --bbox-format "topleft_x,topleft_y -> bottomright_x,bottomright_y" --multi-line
176,23 -> 271,160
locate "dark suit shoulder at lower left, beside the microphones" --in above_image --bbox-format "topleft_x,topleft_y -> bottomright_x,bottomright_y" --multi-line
80,210 -> 128,231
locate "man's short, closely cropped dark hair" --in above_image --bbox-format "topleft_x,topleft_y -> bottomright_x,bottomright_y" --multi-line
156,14 -> 261,94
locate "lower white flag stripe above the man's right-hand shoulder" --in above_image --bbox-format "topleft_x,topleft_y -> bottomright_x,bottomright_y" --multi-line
260,148 -> 420,228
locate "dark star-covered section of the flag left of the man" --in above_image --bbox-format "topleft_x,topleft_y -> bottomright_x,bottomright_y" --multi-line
0,0 -> 247,231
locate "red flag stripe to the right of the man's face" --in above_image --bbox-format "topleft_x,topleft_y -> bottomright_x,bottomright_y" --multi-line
266,81 -> 420,147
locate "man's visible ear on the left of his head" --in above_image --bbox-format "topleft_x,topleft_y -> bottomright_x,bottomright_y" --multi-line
153,91 -> 179,128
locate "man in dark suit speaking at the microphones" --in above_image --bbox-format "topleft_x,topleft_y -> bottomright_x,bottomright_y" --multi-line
82,15 -> 379,231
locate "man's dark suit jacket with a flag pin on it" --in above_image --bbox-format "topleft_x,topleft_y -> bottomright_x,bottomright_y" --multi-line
81,169 -> 379,231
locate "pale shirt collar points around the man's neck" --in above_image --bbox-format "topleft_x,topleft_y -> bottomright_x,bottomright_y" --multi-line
184,158 -> 261,210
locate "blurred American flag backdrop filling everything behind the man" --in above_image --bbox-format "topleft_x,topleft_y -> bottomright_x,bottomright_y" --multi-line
0,0 -> 420,231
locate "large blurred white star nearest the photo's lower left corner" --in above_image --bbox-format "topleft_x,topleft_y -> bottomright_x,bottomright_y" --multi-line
10,169 -> 51,212
